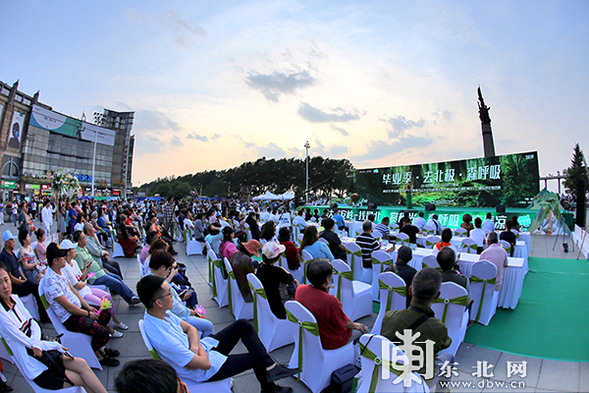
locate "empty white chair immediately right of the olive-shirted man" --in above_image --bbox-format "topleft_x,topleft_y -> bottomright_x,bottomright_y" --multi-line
432,281 -> 468,356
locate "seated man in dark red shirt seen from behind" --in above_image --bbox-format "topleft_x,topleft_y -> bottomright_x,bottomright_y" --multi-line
295,258 -> 367,349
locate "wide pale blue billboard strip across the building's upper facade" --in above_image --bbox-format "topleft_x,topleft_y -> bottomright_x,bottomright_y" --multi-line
30,105 -> 116,146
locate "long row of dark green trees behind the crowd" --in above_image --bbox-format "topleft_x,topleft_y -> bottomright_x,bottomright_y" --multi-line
138,156 -> 354,197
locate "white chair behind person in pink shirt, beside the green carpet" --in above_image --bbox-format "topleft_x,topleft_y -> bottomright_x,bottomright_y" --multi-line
470,261 -> 499,326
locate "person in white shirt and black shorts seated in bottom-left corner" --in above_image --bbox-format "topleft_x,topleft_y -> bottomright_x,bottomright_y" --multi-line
0,264 -> 106,393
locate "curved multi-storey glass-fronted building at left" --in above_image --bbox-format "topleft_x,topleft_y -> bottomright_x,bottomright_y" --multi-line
0,82 -> 134,199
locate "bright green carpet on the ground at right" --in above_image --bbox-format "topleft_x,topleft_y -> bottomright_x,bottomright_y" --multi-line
464,257 -> 589,362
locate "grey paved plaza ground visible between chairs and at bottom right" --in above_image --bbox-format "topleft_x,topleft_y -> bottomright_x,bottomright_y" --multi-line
0,219 -> 589,393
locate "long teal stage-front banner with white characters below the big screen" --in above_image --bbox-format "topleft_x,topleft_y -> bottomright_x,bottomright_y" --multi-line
305,204 -> 573,231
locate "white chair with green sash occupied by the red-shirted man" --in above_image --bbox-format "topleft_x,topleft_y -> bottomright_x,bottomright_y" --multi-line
285,300 -> 354,393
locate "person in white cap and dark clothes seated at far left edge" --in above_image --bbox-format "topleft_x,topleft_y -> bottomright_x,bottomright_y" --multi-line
0,229 -> 49,322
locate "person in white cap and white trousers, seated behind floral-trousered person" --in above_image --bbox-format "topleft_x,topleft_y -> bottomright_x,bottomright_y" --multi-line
59,239 -> 129,338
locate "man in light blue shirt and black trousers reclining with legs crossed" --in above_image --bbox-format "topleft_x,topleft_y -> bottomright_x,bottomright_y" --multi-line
137,274 -> 298,392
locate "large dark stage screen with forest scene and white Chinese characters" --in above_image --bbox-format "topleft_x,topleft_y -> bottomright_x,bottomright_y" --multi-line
354,152 -> 540,208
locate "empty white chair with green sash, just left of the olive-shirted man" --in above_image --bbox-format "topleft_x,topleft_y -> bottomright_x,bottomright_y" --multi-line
371,272 -> 409,334
